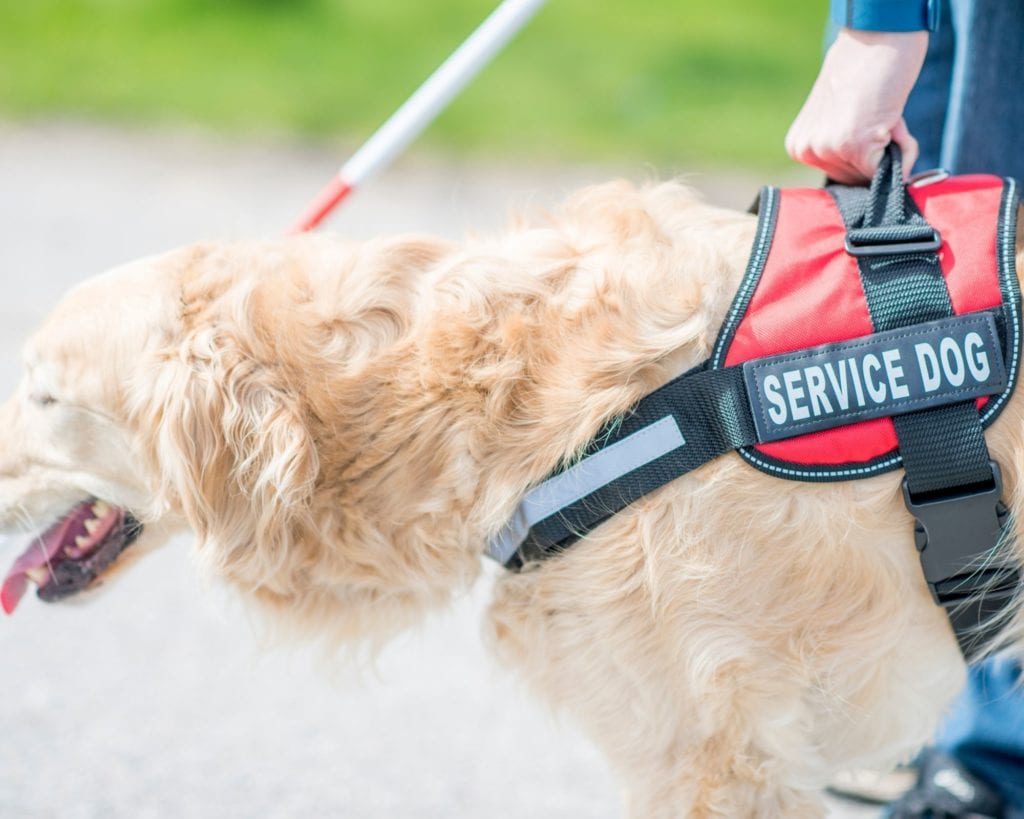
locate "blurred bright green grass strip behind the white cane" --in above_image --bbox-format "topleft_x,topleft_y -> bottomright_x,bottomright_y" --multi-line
0,0 -> 825,166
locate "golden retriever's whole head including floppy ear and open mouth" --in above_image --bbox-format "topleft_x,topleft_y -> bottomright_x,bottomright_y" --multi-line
0,243 -> 316,612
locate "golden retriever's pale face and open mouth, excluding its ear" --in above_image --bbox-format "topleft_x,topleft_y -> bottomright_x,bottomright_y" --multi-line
0,257 -> 172,612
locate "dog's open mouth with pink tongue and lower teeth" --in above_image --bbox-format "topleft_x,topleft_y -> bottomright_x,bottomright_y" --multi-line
0,499 -> 142,614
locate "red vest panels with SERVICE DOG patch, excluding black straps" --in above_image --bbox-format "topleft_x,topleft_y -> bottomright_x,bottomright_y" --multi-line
712,175 -> 1020,480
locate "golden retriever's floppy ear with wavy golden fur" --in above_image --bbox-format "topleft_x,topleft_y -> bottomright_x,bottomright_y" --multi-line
150,330 -> 318,586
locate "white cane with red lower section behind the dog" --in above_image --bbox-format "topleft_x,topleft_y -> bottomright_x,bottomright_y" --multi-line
290,0 -> 547,233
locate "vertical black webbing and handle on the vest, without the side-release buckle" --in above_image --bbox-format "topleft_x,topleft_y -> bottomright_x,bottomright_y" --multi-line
828,145 -> 992,497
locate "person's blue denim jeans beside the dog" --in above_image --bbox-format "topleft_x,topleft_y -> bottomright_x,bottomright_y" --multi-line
905,0 -> 1024,810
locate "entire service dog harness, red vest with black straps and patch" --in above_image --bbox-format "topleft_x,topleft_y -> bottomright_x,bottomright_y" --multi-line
487,150 -> 1021,654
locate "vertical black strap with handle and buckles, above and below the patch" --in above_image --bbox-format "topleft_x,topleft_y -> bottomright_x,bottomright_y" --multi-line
827,145 -> 1019,657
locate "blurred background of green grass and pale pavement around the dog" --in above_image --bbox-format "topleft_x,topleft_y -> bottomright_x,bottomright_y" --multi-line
0,0 -> 856,819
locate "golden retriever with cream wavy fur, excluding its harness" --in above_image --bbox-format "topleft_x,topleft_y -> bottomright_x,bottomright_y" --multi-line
0,183 -> 1024,819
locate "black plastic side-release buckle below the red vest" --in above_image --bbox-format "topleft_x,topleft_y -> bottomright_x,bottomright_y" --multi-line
903,461 -> 1010,605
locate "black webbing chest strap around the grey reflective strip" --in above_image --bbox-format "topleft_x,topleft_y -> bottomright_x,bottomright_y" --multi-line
507,367 -> 757,568
